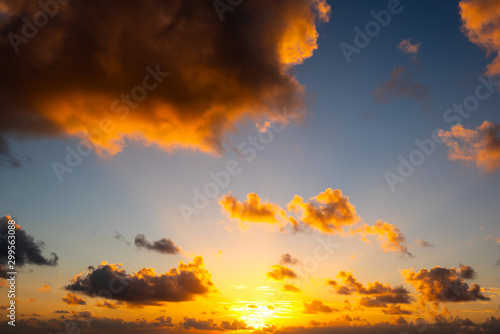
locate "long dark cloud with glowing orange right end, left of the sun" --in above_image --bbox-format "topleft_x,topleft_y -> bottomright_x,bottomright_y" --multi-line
65,256 -> 216,305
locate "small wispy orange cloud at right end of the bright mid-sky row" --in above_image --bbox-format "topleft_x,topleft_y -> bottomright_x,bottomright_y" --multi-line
350,220 -> 413,257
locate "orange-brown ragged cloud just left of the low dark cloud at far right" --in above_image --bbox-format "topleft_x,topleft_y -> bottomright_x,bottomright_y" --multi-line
327,271 -> 413,307
